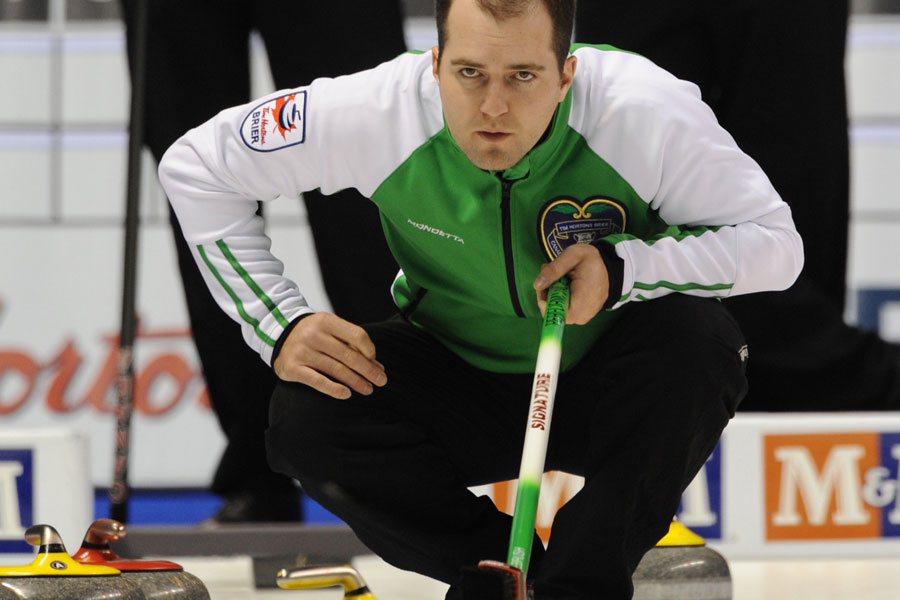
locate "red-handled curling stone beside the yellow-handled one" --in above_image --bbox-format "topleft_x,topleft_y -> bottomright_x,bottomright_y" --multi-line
72,519 -> 209,600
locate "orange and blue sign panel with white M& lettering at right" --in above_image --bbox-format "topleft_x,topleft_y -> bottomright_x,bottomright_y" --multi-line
764,432 -> 900,540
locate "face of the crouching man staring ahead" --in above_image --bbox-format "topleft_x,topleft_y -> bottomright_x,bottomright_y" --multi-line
432,0 -> 575,171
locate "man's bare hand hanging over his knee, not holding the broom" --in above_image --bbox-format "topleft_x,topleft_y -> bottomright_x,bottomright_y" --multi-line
274,313 -> 387,399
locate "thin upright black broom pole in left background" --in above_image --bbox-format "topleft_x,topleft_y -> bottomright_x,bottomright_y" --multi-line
109,0 -> 148,523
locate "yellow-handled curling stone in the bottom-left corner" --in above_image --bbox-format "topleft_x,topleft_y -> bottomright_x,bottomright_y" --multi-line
0,525 -> 144,600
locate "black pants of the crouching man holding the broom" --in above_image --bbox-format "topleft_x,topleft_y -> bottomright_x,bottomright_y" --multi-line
267,294 -> 746,599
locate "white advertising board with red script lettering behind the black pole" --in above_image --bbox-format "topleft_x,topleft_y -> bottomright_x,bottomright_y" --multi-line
0,218 -> 330,487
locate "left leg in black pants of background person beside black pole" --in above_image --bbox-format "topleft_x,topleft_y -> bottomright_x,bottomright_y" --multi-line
123,0 -> 301,521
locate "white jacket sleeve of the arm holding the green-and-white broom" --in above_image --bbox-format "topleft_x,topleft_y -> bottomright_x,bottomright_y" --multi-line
573,49 -> 803,306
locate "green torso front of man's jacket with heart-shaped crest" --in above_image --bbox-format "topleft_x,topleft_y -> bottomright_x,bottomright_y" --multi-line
372,92 -> 666,372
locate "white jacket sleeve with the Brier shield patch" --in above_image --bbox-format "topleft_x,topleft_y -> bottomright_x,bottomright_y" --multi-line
159,55 -> 442,363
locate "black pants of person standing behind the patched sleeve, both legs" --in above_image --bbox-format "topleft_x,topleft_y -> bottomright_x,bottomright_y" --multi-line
123,0 -> 405,495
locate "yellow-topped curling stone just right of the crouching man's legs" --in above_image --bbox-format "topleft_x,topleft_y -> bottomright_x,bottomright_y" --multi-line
631,521 -> 731,600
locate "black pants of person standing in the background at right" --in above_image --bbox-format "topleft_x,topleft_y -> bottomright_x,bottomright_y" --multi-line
576,0 -> 900,411
